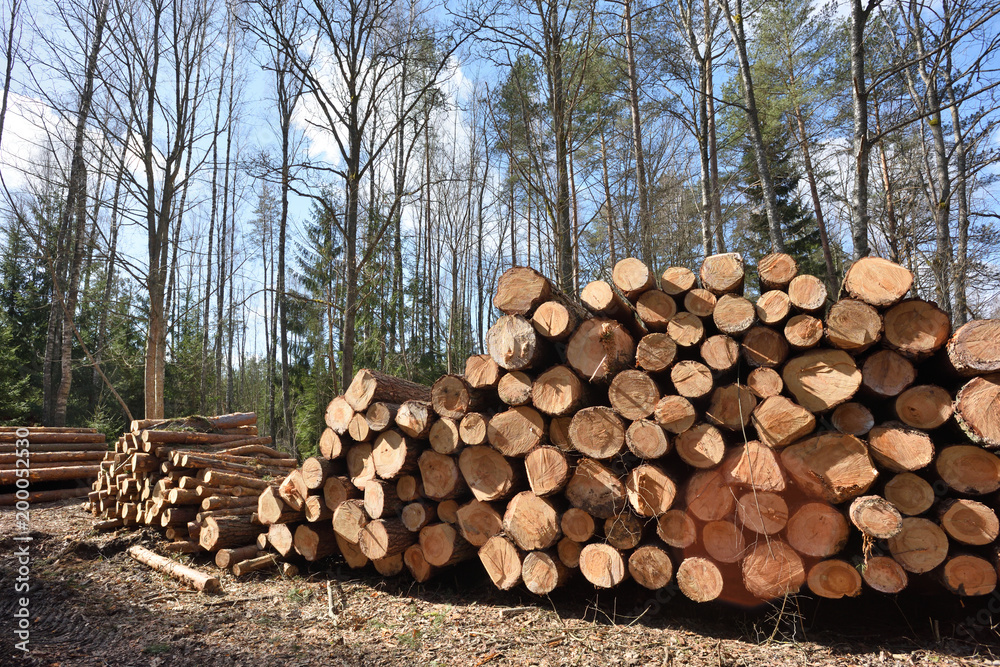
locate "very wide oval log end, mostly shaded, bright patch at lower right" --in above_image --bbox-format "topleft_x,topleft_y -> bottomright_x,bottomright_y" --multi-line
781,431 -> 878,504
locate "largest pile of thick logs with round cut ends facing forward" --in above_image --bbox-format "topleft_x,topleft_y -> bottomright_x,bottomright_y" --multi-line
258,254 -> 1000,604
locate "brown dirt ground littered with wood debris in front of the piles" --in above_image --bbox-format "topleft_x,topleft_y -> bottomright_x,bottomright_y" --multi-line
0,501 -> 1000,667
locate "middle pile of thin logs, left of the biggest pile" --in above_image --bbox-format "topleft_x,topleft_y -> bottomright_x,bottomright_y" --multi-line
89,412 -> 298,572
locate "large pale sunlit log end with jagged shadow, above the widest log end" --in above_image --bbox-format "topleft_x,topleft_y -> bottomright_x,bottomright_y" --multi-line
781,350 -> 861,412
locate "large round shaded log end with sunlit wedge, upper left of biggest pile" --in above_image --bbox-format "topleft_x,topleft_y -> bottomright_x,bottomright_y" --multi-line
566,317 -> 635,384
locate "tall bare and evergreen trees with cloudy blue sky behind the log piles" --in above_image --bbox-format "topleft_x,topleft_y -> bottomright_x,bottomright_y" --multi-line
0,0 -> 1000,455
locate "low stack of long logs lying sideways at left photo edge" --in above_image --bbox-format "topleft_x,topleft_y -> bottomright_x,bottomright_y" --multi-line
0,426 -> 107,506
